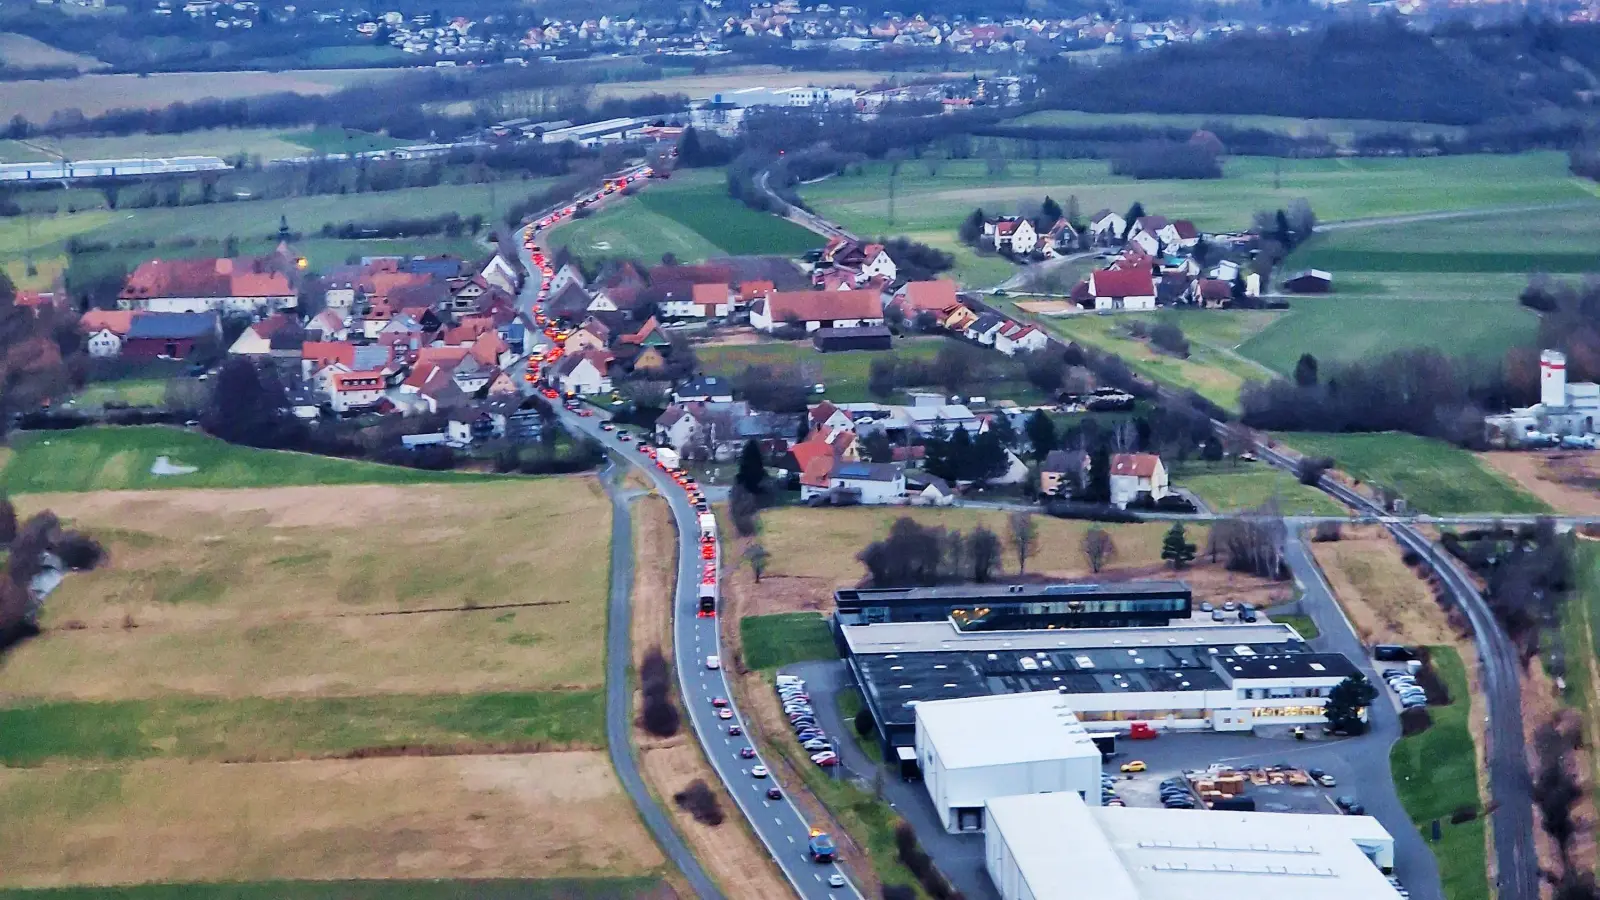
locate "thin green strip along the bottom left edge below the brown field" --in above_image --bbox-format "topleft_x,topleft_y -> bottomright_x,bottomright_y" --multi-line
0,878 -> 664,900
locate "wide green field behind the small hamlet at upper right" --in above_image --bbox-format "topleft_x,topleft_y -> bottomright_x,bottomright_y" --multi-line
800,152 -> 1592,235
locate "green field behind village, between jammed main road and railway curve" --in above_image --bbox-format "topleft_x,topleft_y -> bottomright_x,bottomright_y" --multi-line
550,170 -> 822,263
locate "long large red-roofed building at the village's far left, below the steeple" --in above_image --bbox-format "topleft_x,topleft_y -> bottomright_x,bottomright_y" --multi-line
117,258 -> 296,312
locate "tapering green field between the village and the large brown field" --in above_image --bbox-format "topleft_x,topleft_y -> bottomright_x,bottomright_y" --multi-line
0,424 -> 490,493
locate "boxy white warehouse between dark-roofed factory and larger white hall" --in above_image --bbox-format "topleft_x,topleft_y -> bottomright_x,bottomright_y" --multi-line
915,690 -> 1101,834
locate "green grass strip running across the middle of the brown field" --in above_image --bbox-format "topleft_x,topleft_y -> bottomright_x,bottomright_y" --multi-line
0,689 -> 605,767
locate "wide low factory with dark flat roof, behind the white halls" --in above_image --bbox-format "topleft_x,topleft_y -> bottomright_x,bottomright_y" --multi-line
837,618 -> 1357,759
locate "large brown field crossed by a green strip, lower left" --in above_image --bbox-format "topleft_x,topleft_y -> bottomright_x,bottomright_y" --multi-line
0,477 -> 664,897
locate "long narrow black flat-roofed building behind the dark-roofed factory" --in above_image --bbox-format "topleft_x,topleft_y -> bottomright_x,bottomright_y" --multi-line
834,581 -> 1194,631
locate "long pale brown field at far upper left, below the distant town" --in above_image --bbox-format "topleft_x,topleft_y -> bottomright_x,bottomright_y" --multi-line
0,69 -> 397,122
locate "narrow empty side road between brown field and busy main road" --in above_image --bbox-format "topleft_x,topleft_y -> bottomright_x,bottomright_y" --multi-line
600,463 -> 723,900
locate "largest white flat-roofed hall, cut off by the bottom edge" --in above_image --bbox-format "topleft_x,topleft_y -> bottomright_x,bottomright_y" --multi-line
984,791 -> 1400,900
